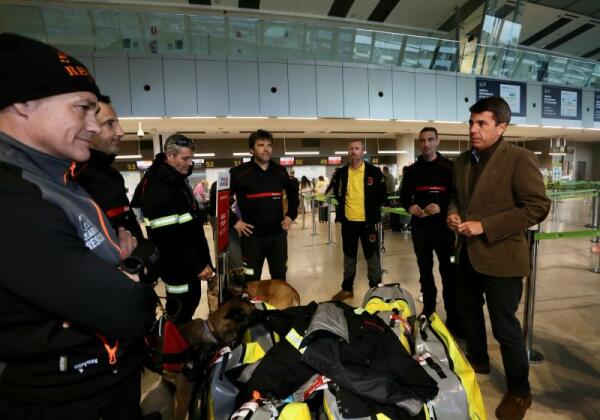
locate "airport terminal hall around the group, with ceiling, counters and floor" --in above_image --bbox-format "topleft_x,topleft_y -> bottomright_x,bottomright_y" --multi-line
0,0 -> 600,420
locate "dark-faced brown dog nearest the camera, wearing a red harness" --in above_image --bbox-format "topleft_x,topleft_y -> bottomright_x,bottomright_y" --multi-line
149,297 -> 261,420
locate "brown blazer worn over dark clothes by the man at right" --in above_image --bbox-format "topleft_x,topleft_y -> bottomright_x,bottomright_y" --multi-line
448,141 -> 550,277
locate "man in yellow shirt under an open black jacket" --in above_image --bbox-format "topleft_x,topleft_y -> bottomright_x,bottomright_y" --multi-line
330,140 -> 386,301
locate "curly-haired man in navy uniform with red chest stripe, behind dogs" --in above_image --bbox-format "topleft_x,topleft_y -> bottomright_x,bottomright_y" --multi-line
230,130 -> 299,281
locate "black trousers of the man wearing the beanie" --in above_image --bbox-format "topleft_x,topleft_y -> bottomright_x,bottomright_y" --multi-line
0,372 -> 142,420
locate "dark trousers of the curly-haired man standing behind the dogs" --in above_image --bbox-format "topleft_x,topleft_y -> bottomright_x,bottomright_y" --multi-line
240,232 -> 287,281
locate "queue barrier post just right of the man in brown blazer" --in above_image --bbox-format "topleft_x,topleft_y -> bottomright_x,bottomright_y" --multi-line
523,225 -> 544,364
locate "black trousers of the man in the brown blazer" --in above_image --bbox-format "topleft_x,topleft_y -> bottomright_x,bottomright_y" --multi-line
458,245 -> 530,395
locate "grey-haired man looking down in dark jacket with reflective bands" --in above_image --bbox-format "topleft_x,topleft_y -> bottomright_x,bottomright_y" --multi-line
132,134 -> 214,322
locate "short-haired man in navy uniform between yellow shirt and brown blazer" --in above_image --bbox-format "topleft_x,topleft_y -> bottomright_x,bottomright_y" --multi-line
400,127 -> 462,334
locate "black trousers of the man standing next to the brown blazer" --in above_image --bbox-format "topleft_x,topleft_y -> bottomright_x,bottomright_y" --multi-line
411,225 -> 458,322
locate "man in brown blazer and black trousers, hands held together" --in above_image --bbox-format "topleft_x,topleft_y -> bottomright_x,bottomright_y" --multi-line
447,97 -> 550,419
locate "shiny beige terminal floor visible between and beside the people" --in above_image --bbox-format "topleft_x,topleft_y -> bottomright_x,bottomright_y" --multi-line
145,200 -> 600,420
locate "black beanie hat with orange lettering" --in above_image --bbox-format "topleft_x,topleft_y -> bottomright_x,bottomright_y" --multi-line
0,33 -> 100,109
